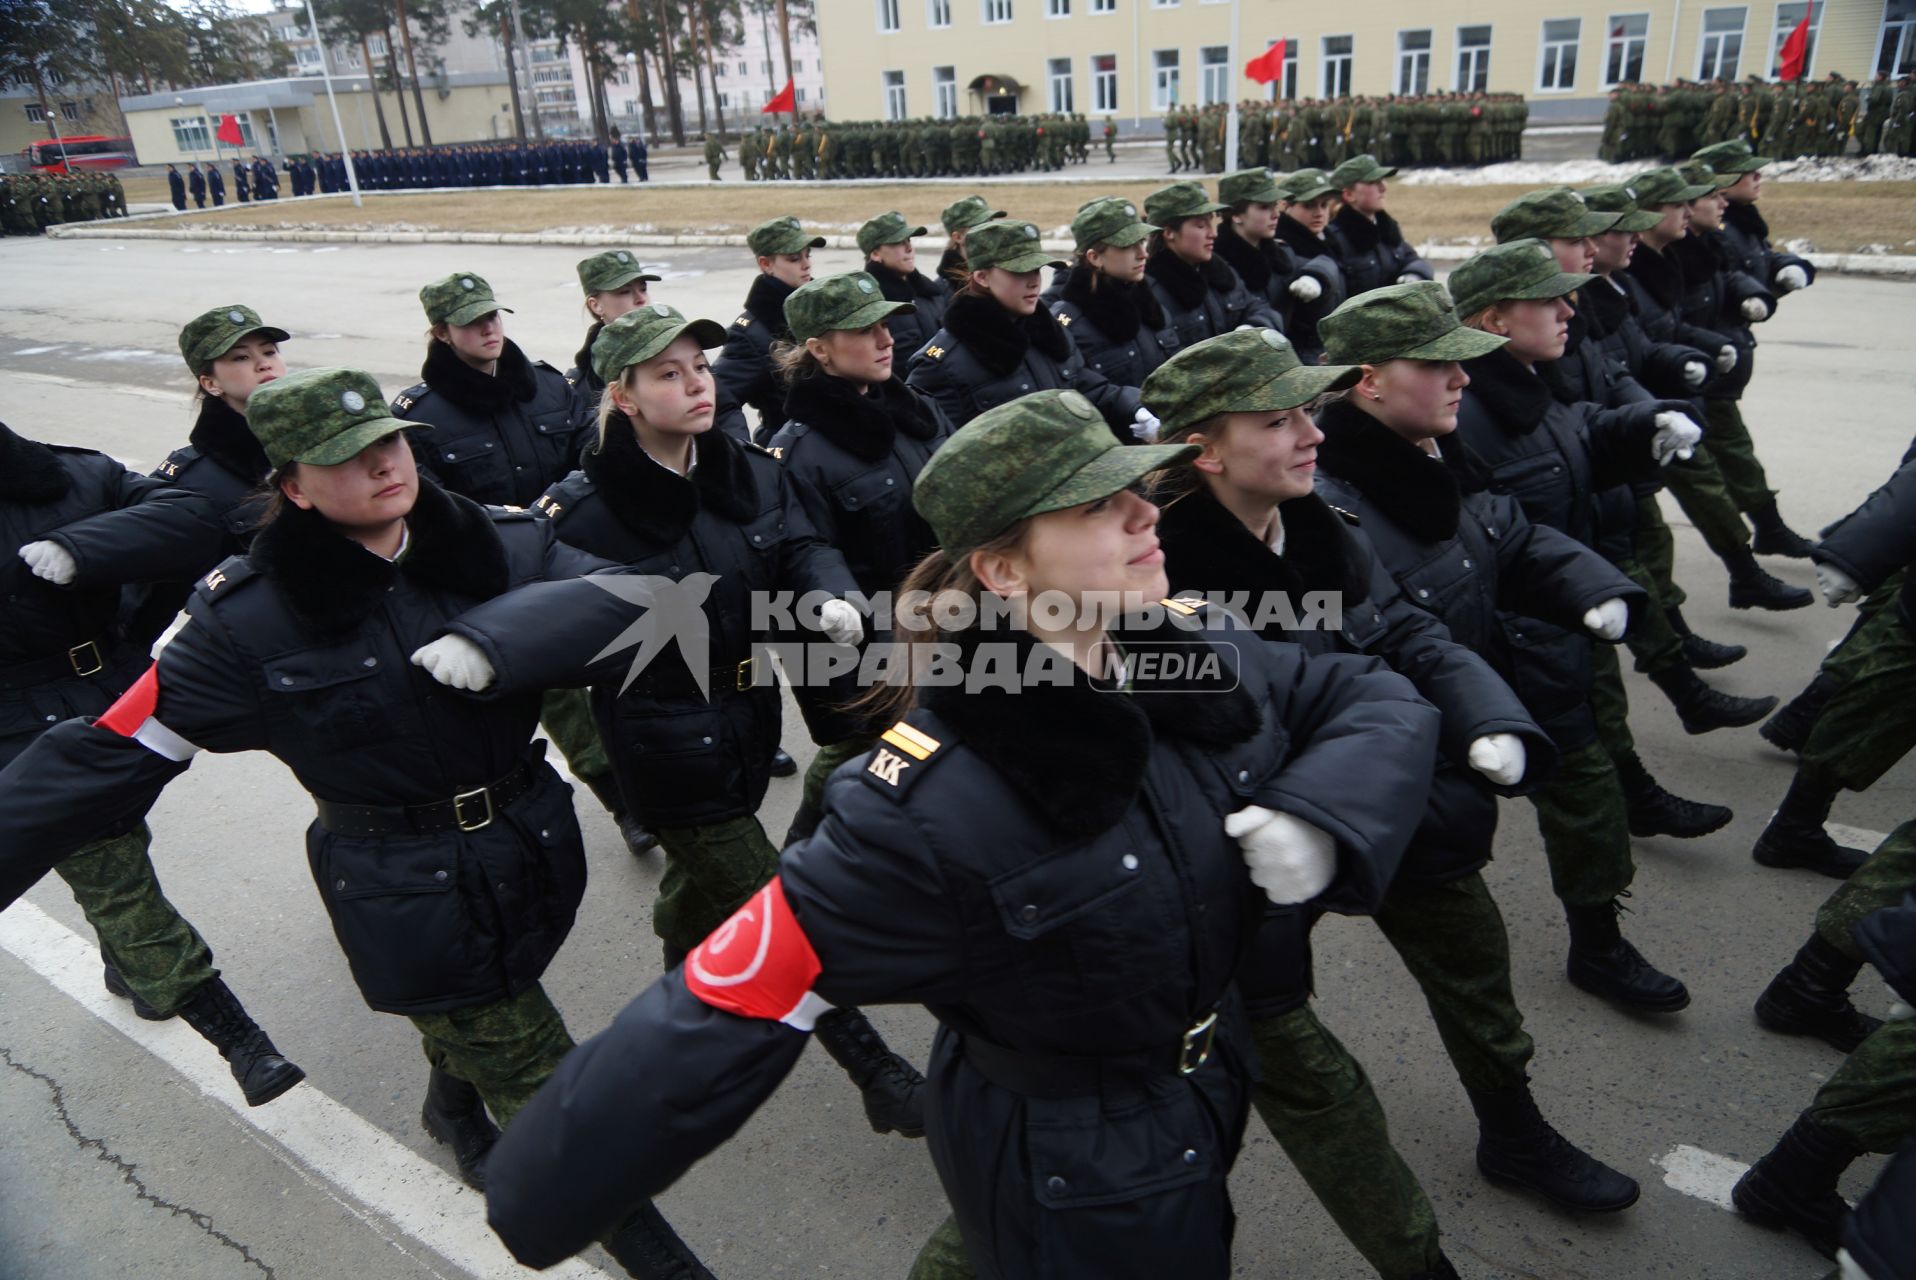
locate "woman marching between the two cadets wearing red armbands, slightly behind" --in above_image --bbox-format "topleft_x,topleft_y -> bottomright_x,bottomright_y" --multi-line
535,304 -> 924,1136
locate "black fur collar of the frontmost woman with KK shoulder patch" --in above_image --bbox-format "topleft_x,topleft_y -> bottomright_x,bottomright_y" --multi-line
925,629 -> 1263,839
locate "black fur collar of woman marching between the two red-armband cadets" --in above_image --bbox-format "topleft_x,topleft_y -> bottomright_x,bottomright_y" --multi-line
581,420 -> 759,542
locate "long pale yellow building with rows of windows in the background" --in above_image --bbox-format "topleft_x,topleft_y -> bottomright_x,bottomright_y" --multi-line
818,0 -> 1916,125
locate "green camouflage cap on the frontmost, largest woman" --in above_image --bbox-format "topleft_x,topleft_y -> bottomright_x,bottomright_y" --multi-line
912,391 -> 1199,561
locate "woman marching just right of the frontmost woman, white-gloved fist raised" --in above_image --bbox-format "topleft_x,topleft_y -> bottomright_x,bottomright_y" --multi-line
1144,331 -> 1638,1280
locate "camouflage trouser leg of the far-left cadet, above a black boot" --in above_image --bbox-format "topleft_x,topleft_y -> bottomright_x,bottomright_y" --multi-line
54,822 -> 220,1016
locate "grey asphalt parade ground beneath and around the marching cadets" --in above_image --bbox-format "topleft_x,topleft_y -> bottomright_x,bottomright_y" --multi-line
0,228 -> 1916,1280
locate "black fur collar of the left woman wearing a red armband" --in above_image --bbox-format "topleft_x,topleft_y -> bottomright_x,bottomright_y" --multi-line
247,475 -> 510,636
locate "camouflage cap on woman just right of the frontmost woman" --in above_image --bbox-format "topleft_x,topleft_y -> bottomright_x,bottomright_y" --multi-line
1144,330 -> 1358,435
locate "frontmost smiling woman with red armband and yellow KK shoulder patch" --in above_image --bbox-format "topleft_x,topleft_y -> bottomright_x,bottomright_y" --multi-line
489,387 -> 1435,1280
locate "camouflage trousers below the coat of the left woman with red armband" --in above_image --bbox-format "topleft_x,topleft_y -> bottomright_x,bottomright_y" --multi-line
412,983 -> 573,1129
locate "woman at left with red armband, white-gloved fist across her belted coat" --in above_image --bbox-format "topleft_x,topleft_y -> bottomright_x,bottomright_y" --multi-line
0,368 -> 712,1274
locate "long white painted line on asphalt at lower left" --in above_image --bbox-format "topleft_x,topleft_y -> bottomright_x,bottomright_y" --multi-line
0,901 -> 605,1280
